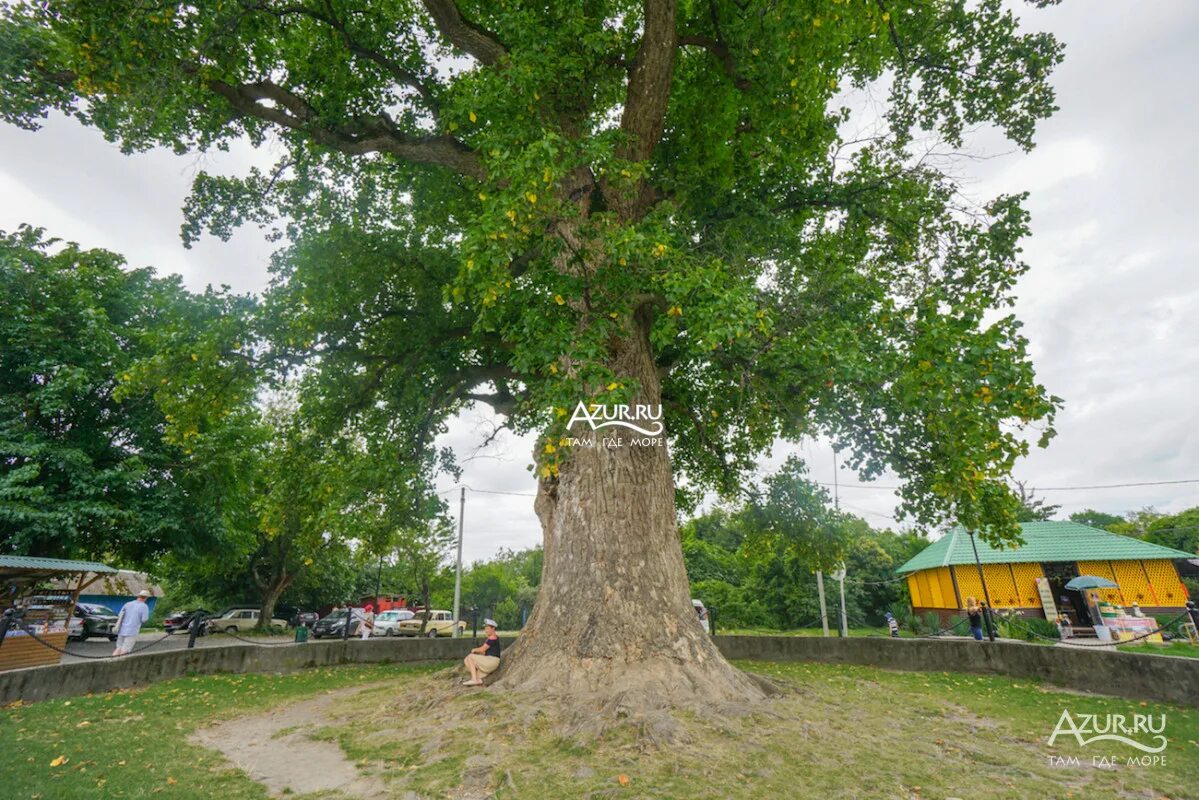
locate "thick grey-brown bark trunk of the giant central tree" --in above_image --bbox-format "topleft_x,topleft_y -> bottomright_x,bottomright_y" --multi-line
498,309 -> 763,717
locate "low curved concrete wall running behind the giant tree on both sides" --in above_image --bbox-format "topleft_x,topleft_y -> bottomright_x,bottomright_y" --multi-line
0,636 -> 1199,706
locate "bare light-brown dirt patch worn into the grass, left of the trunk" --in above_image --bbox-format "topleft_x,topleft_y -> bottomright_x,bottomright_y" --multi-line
191,686 -> 394,800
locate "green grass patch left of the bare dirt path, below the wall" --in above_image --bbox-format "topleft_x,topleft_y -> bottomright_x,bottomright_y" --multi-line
0,664 -> 440,800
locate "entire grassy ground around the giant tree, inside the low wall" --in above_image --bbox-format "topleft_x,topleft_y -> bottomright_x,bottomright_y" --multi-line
0,662 -> 1199,800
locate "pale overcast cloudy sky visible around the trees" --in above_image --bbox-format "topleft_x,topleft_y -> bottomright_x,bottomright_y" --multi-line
0,0 -> 1199,560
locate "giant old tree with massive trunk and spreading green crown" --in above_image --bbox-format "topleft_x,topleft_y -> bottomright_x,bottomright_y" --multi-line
0,0 -> 1060,710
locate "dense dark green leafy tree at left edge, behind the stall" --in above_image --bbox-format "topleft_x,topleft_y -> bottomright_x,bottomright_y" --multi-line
0,228 -> 253,567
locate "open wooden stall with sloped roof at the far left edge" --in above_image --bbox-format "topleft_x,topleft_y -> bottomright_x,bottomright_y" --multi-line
0,555 -> 116,669
